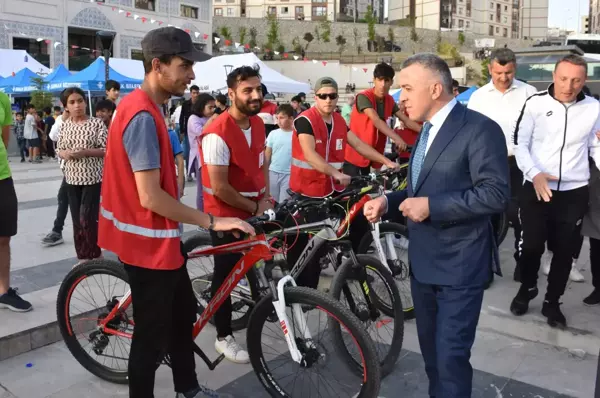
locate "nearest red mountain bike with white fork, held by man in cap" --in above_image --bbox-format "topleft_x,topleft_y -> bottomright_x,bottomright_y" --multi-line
57,212 -> 381,398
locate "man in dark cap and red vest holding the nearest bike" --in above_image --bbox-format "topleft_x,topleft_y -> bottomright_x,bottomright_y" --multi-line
98,27 -> 254,398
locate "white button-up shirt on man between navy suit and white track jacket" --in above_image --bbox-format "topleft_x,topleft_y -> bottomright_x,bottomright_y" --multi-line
467,79 -> 538,156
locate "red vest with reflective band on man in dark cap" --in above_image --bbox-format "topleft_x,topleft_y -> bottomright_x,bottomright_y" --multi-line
98,89 -> 183,270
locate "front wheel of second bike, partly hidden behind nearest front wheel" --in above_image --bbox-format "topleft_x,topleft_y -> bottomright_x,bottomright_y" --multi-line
330,254 -> 404,377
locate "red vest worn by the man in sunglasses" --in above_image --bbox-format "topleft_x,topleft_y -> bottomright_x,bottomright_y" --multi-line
290,107 -> 348,198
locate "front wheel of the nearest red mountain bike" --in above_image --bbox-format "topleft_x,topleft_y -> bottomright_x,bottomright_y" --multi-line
247,287 -> 381,398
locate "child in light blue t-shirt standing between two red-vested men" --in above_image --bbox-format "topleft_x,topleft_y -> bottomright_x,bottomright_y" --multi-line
265,104 -> 294,202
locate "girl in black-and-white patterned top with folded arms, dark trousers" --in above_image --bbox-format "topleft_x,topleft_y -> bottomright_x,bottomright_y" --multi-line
57,87 -> 107,265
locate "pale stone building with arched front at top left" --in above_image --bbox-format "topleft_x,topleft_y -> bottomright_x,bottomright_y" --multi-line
0,0 -> 212,71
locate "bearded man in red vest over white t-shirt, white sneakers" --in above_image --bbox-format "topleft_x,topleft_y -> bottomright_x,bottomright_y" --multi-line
201,66 -> 273,363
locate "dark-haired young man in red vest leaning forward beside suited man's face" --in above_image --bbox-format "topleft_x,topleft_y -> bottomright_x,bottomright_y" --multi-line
344,62 -> 421,176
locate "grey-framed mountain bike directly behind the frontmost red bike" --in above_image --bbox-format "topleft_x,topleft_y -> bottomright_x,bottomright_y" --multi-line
184,191 -> 404,376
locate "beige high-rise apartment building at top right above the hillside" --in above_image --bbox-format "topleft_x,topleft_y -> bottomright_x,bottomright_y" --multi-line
388,0 -> 548,39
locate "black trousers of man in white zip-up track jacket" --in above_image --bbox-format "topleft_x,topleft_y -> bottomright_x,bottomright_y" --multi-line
518,181 -> 588,302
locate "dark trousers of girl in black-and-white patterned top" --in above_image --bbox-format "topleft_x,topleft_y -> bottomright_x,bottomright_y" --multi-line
65,183 -> 102,260
